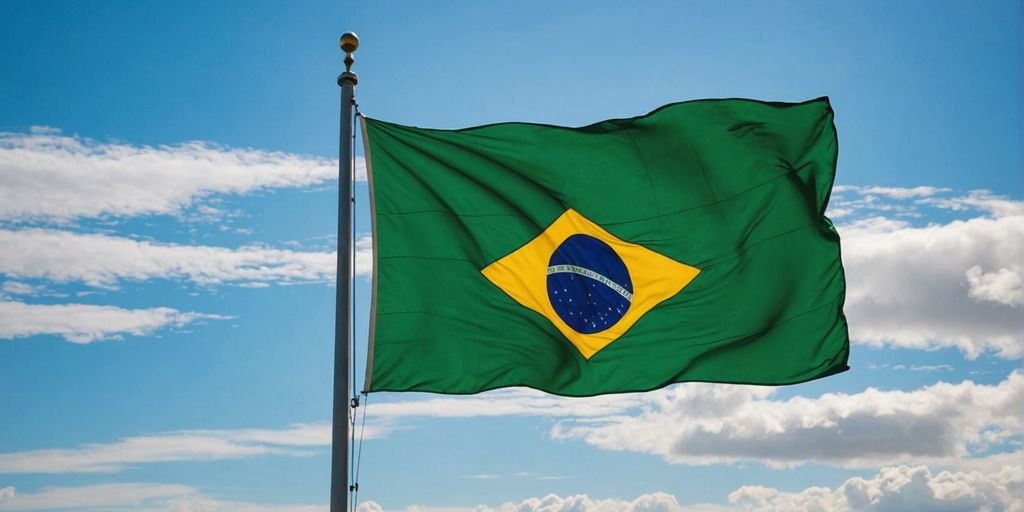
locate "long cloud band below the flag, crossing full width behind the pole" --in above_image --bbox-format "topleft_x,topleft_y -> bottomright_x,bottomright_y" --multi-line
0,373 -> 1024,473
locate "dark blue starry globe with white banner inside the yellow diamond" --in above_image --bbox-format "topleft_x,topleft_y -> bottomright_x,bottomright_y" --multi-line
548,234 -> 633,334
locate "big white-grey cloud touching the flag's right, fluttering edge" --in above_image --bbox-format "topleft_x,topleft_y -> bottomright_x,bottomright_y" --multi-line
839,198 -> 1024,358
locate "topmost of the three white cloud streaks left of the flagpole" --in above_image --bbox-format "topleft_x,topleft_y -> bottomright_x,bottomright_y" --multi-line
0,129 -> 366,220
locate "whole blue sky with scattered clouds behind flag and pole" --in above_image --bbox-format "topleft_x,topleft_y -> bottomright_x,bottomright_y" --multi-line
0,1 -> 1024,512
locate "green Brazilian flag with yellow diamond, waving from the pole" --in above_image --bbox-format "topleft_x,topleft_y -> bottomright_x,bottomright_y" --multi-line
362,98 -> 849,396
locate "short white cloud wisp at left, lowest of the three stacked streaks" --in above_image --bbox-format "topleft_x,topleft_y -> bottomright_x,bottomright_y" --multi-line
0,299 -> 226,343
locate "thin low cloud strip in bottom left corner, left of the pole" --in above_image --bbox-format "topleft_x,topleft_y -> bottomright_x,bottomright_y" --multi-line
0,483 -> 328,512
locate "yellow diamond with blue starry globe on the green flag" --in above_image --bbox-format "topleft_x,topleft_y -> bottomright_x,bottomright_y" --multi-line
481,209 -> 700,359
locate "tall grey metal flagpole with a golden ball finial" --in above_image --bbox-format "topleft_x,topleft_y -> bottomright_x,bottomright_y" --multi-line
331,32 -> 359,512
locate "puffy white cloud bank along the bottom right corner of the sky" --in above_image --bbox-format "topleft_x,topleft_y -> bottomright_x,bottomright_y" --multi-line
729,466 -> 1024,512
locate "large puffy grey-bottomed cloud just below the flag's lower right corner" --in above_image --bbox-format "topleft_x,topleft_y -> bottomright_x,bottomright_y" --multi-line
552,373 -> 1024,468
